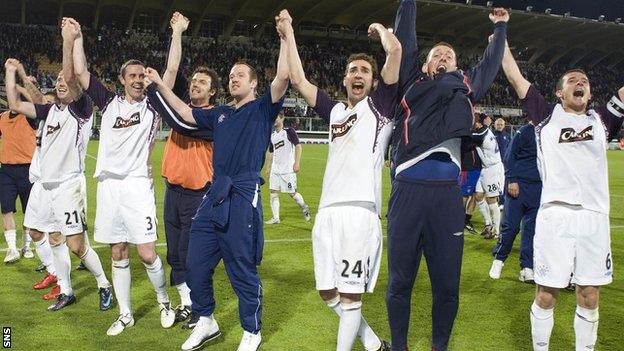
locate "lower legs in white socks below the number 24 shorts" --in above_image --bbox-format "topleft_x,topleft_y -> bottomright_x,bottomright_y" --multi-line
319,289 -> 385,351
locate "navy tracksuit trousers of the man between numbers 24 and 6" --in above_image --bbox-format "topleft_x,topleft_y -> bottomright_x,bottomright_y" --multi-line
386,179 -> 465,350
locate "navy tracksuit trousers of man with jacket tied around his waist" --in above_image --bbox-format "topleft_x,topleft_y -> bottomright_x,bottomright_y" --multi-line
187,193 -> 264,333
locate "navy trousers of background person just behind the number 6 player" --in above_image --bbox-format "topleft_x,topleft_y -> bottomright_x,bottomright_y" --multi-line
492,180 -> 542,269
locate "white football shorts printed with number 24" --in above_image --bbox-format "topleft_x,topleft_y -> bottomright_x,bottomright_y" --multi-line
312,205 -> 382,294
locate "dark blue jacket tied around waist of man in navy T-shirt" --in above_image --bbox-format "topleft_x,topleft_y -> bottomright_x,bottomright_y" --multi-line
205,172 -> 260,229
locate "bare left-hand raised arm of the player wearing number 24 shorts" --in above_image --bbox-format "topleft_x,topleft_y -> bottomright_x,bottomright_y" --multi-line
276,10 -> 318,107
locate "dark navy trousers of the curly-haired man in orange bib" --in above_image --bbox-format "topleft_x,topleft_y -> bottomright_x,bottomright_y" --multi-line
164,181 -> 205,285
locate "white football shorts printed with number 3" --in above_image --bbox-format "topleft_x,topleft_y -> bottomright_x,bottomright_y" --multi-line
94,177 -> 157,244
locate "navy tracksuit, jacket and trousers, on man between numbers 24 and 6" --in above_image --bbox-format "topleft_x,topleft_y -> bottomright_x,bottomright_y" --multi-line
386,0 -> 507,350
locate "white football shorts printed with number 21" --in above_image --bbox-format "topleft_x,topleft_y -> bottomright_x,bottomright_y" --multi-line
24,175 -> 87,235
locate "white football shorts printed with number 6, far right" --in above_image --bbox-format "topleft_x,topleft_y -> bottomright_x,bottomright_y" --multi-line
533,204 -> 613,288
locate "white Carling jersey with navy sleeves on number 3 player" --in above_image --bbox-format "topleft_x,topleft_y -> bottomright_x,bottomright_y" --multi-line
87,75 -> 160,177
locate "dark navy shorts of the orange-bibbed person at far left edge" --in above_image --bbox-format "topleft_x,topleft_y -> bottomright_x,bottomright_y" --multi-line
0,164 -> 32,213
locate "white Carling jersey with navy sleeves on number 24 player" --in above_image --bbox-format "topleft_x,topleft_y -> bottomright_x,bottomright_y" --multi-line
314,80 -> 397,214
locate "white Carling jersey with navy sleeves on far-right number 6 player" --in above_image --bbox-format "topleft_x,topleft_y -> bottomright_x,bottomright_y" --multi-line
523,87 -> 622,214
